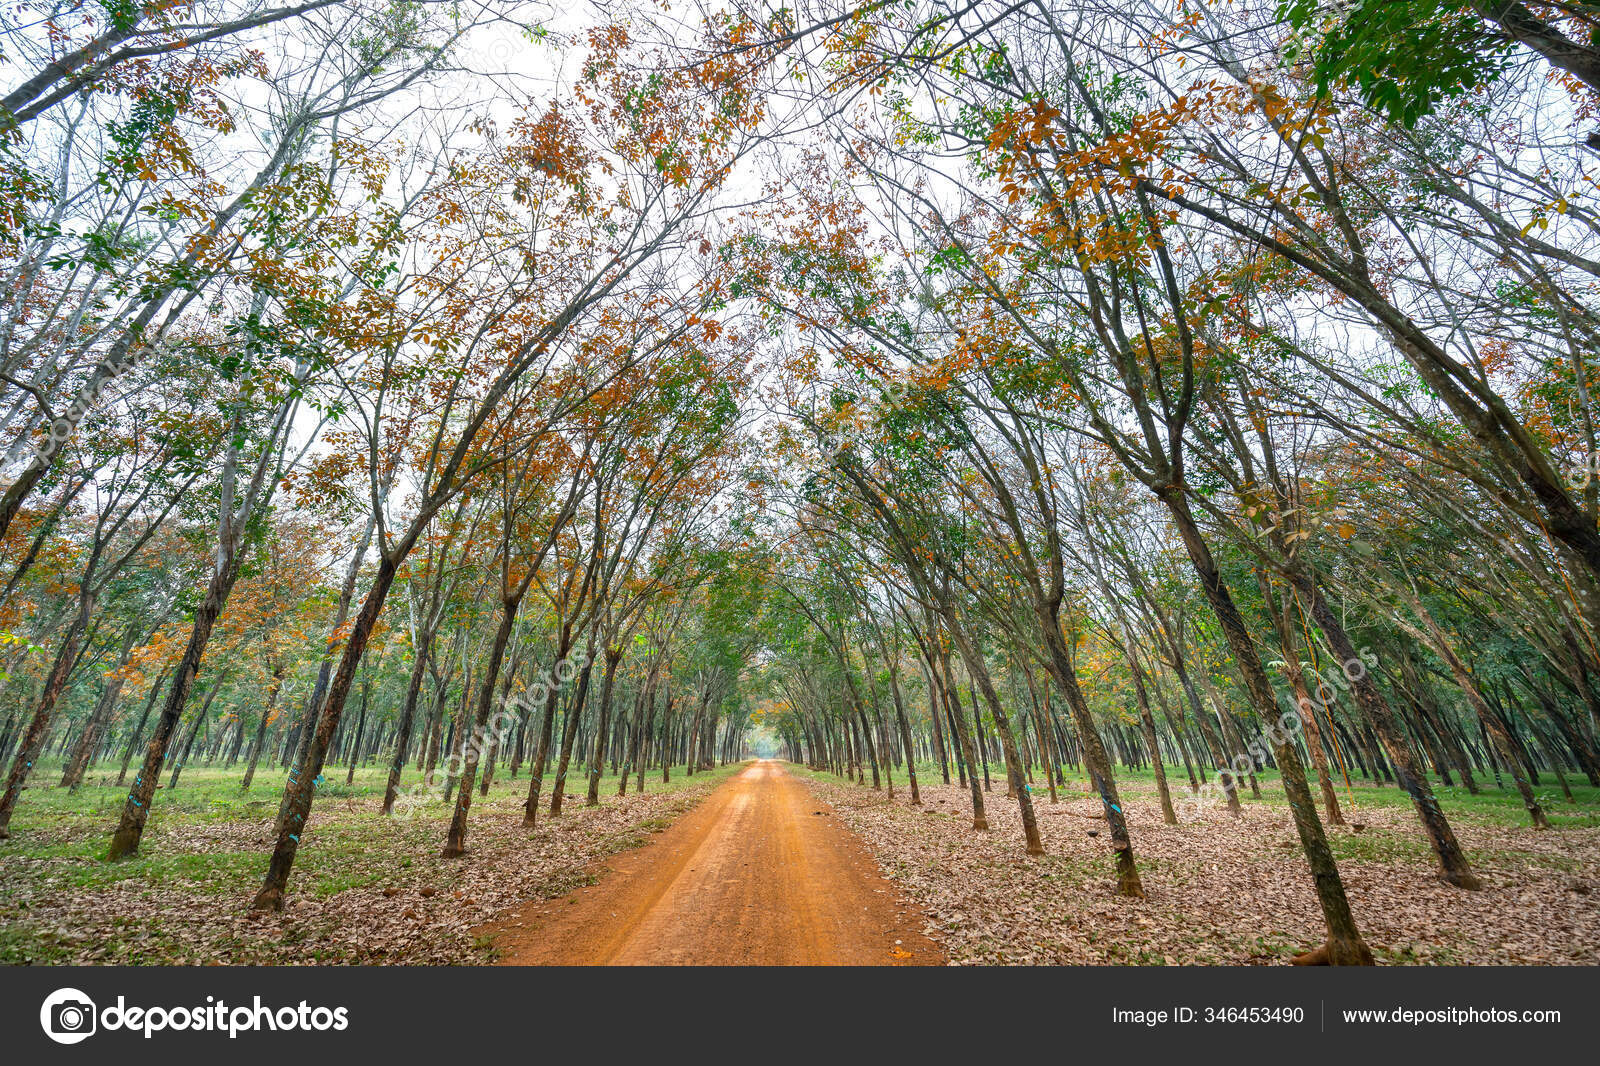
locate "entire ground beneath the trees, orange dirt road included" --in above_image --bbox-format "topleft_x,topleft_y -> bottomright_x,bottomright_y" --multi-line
0,745 -> 1600,965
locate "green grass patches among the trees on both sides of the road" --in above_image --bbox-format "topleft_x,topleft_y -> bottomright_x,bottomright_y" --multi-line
9,745 -> 1600,964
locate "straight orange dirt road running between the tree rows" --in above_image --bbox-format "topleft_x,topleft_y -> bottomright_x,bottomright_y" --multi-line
480,760 -> 944,965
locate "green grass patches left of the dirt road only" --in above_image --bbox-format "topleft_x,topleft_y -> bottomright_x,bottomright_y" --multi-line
0,745 -> 741,964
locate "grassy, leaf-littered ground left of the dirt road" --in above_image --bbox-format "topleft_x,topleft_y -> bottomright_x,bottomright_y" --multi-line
0,763 -> 741,965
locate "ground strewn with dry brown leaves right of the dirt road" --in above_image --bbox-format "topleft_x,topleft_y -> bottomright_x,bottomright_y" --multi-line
806,767 -> 1600,965
